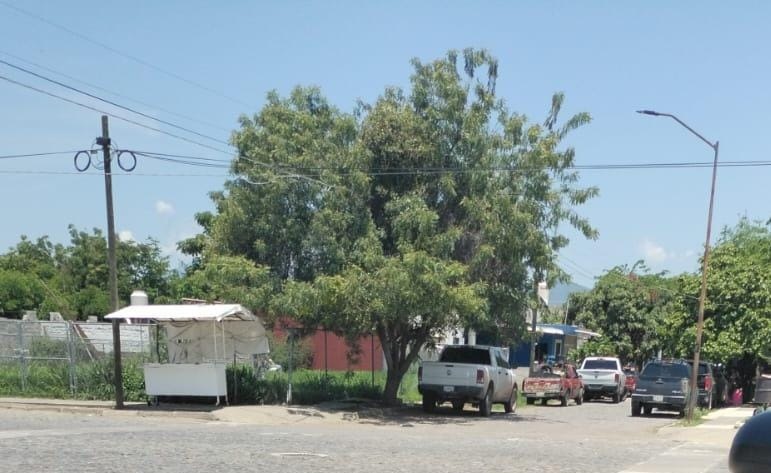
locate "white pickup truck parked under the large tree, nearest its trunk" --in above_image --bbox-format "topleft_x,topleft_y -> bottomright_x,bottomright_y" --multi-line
418,345 -> 517,417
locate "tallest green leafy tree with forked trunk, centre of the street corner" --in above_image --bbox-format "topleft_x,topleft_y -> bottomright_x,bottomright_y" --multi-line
181,49 -> 596,402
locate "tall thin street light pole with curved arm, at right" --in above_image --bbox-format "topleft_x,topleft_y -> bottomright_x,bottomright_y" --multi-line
637,110 -> 720,420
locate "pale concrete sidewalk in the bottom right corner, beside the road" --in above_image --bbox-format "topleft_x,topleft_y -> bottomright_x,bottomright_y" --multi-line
620,407 -> 753,473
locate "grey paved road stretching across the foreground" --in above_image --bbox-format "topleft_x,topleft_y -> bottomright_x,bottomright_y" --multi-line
0,401 -> 727,473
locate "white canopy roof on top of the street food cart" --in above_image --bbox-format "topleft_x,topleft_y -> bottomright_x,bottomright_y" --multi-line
104,304 -> 258,322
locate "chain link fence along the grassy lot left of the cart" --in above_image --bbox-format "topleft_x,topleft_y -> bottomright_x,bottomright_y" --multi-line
0,318 -> 157,399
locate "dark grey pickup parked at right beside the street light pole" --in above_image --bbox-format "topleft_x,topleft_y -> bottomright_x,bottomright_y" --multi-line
632,360 -> 692,417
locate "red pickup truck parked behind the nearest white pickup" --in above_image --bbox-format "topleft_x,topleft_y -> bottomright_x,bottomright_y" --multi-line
522,364 -> 584,406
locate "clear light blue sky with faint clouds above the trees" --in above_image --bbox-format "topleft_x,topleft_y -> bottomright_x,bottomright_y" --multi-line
0,0 -> 771,285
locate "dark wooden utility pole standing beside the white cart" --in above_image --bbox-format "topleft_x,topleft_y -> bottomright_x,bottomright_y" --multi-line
96,115 -> 123,409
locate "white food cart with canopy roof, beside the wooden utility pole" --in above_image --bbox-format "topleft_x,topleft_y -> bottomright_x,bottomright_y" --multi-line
105,304 -> 269,405
